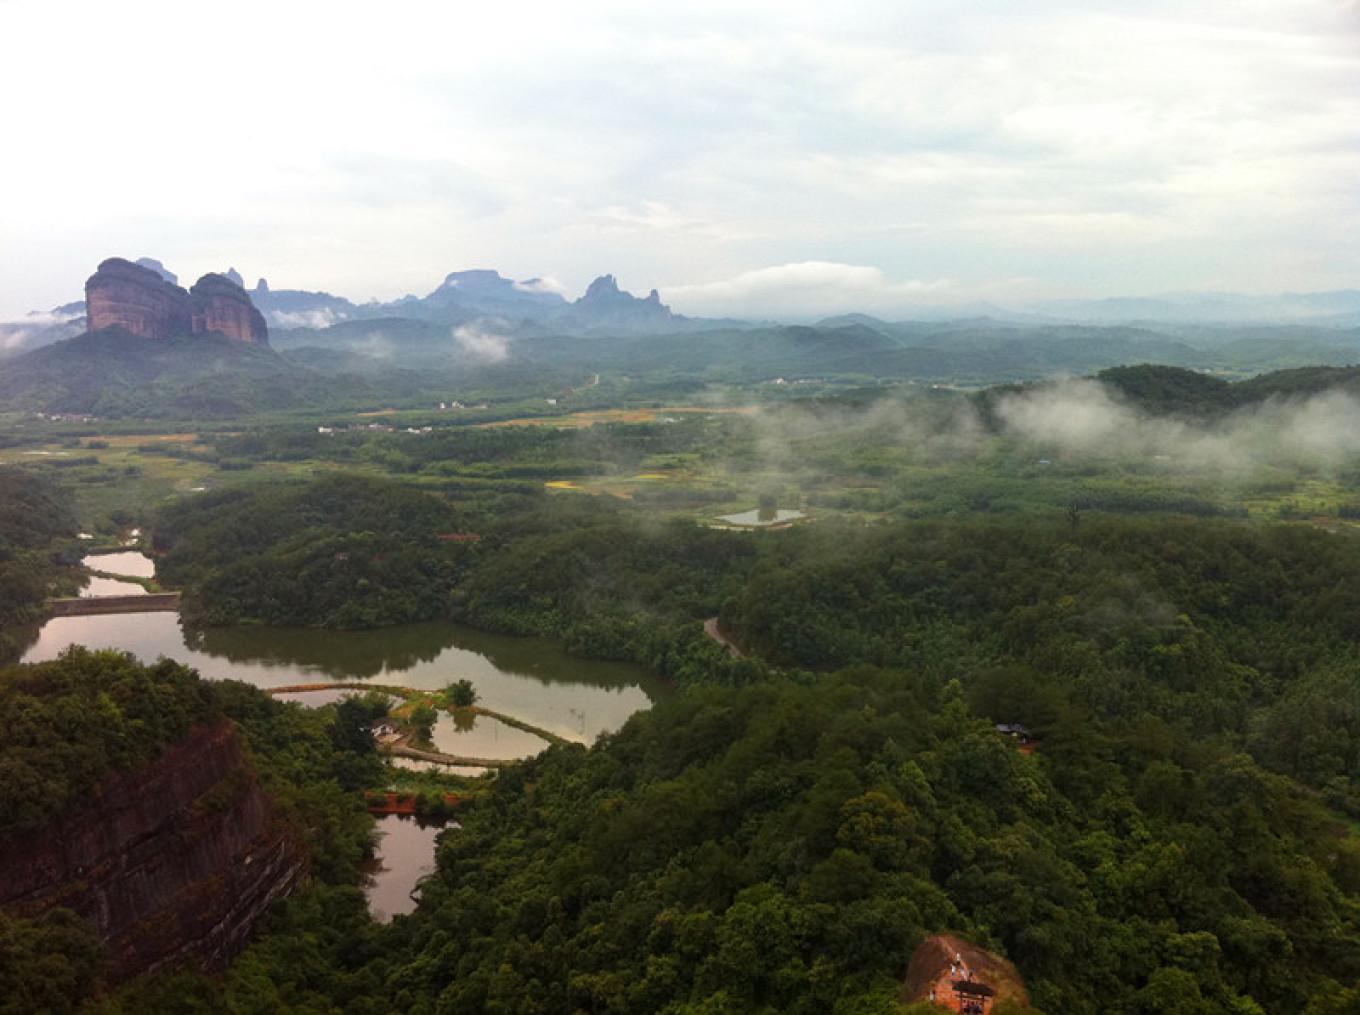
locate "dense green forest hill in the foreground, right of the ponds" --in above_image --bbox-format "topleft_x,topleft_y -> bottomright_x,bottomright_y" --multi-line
85,655 -> 1360,1015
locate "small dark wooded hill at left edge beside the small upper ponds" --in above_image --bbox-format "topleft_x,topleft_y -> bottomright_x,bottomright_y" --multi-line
0,468 -> 76,661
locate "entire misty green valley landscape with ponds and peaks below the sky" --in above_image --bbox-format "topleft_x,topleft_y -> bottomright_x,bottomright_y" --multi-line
0,254 -> 1360,1015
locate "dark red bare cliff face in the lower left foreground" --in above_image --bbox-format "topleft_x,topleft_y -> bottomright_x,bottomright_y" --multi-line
0,720 -> 307,984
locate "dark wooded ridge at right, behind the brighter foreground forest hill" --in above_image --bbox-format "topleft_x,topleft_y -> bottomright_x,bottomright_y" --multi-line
722,517 -> 1360,816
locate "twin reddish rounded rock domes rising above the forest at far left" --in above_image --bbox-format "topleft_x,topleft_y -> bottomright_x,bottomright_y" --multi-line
86,257 -> 269,344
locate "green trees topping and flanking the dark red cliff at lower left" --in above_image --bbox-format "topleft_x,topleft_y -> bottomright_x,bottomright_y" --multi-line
0,649 -> 386,1012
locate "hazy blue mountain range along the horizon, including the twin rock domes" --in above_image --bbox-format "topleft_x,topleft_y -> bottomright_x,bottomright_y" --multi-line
0,259 -> 1360,418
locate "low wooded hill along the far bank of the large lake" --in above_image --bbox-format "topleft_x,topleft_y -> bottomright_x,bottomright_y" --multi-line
155,475 -> 758,680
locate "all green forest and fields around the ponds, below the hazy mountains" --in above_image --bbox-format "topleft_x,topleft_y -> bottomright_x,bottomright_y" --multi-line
0,356 -> 1360,1015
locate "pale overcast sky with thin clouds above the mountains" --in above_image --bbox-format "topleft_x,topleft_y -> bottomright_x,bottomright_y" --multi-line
0,0 -> 1360,318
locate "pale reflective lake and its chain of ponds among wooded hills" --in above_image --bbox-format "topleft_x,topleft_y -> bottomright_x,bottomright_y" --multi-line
22,552 -> 666,918
